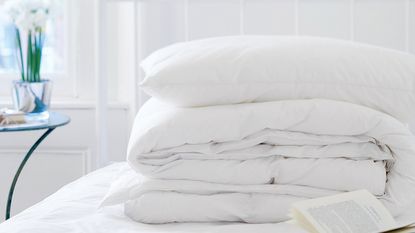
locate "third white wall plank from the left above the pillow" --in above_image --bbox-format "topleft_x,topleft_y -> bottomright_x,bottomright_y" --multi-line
243,0 -> 295,35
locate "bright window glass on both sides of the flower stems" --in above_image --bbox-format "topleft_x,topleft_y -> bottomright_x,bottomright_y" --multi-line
0,0 -> 67,76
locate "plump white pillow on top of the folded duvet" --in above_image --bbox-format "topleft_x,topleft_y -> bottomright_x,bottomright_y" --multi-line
141,36 -> 415,121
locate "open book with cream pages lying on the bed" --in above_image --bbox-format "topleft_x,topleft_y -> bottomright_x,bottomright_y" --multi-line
291,190 -> 415,233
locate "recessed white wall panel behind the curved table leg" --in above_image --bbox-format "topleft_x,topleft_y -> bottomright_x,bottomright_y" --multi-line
0,148 -> 89,218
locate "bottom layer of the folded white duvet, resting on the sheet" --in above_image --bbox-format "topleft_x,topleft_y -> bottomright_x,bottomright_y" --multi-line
101,167 -> 338,223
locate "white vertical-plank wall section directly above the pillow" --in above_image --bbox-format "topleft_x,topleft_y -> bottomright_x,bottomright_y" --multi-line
138,0 -> 415,54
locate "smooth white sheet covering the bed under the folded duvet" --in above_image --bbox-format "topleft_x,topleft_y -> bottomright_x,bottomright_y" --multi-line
0,163 -> 305,233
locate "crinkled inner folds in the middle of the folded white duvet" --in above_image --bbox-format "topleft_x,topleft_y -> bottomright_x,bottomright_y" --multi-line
131,130 -> 392,195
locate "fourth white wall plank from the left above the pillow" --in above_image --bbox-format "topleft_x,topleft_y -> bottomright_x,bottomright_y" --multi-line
298,0 -> 351,39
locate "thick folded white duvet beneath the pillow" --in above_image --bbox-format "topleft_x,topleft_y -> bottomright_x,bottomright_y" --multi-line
118,99 -> 415,223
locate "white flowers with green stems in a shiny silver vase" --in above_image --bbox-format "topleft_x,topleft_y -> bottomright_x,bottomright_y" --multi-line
4,0 -> 52,118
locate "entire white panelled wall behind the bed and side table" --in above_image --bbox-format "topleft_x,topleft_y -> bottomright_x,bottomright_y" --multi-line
0,0 -> 415,220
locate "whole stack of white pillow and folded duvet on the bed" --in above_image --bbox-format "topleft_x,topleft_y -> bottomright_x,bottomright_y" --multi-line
103,37 -> 415,223
